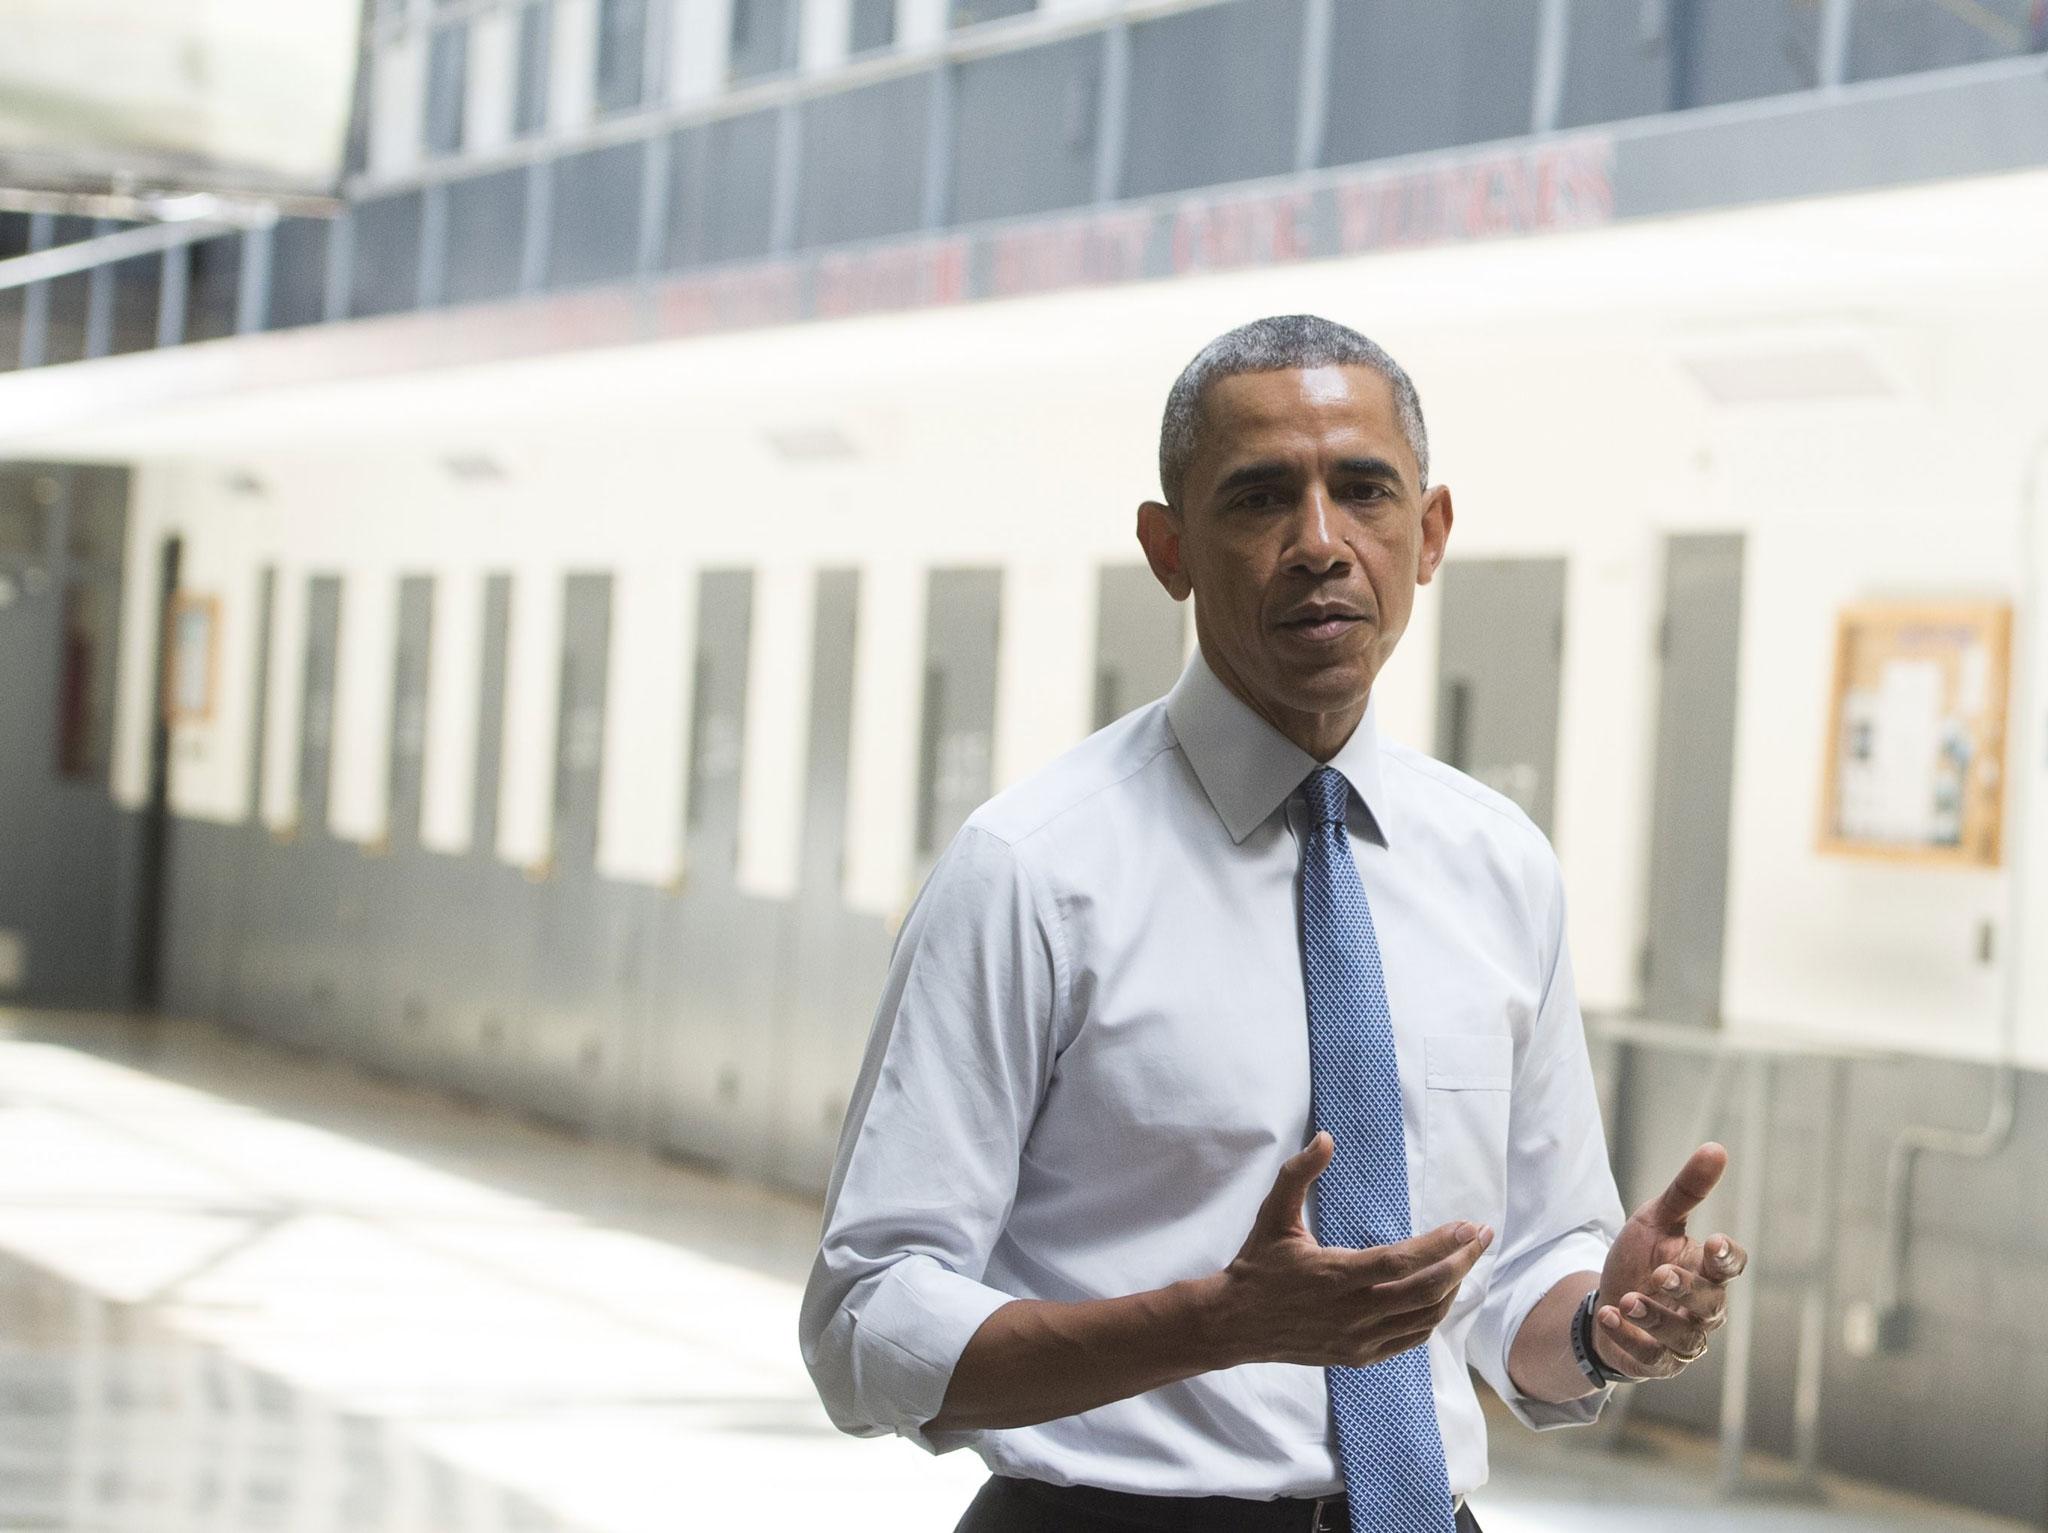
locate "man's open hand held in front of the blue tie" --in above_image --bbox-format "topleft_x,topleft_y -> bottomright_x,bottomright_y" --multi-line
1217,1134 -> 1493,1367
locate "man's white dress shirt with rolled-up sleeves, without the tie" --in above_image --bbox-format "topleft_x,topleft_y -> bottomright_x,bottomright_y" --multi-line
801,653 -> 1622,1498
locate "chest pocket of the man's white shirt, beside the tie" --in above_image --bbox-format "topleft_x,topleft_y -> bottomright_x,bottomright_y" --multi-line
1413,1034 -> 1516,1234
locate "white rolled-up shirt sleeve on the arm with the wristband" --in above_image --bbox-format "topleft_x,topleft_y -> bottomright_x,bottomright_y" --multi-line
1468,847 -> 1622,1431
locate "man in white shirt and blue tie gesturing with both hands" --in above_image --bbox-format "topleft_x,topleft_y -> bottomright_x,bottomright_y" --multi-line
801,315 -> 1745,1533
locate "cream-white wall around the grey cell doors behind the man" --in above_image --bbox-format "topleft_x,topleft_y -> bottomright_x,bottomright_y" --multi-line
96,248 -> 2048,1062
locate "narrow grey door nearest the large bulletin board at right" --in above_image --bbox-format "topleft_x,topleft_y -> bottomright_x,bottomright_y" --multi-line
1642,532 -> 1743,1023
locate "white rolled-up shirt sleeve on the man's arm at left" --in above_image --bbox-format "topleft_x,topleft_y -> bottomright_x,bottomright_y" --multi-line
799,823 -> 1065,1453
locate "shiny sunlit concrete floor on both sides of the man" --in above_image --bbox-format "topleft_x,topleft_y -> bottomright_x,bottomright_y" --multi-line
0,1011 -> 2019,1533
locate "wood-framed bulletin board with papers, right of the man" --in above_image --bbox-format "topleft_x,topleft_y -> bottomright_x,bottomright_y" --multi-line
1821,602 -> 2013,868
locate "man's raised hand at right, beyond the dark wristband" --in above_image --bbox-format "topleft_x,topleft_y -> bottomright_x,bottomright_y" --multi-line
1593,1144 -> 1749,1379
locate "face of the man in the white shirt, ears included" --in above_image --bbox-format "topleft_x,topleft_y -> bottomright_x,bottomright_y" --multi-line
1139,366 -> 1452,753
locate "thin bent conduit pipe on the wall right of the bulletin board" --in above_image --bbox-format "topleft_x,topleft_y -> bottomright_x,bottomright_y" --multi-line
1874,430 -> 2048,1347
